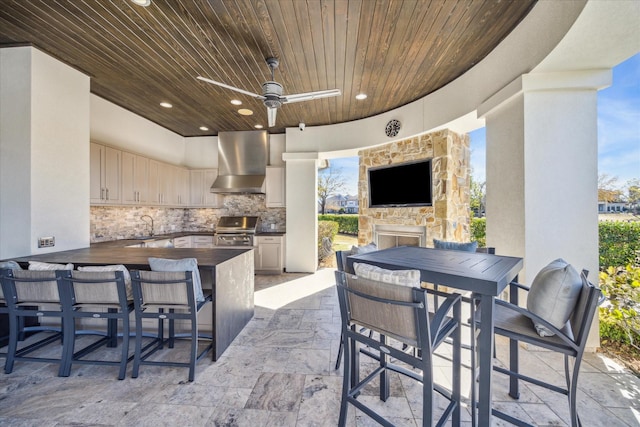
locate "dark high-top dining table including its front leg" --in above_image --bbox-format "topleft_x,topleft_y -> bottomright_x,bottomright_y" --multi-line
347,246 -> 522,426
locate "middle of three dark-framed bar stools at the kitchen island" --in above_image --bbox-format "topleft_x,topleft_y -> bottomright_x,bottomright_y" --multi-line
60,271 -> 133,380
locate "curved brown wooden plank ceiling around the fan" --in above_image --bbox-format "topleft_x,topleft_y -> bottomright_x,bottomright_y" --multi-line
0,0 -> 535,136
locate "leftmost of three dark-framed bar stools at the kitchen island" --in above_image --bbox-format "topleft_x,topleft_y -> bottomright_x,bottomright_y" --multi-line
0,269 -> 68,376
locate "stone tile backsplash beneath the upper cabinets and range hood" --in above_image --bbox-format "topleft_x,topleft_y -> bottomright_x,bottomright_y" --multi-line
90,194 -> 286,243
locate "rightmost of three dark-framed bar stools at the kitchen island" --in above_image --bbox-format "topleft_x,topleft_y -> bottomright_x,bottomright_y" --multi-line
131,271 -> 213,381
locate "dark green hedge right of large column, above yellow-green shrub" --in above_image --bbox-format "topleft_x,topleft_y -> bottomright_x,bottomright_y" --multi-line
598,221 -> 640,269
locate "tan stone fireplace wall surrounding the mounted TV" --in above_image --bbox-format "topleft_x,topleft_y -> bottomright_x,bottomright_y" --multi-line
358,130 -> 471,246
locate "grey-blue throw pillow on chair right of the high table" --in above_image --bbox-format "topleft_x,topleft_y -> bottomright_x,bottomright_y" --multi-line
527,259 -> 582,337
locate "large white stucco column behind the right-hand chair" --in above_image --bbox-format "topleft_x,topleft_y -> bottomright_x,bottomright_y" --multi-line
478,70 -> 611,348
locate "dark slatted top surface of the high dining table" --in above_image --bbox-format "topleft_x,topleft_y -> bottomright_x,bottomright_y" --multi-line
347,246 -> 523,296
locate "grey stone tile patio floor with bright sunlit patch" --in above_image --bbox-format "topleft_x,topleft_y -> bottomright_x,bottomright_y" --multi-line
0,269 -> 640,427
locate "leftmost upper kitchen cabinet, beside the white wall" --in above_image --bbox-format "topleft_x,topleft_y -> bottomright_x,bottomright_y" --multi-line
89,142 -> 122,204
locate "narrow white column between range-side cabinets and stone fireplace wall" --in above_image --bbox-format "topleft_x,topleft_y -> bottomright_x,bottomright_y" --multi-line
282,153 -> 318,273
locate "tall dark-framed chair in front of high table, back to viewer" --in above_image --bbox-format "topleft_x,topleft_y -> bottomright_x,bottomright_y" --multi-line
336,271 -> 460,426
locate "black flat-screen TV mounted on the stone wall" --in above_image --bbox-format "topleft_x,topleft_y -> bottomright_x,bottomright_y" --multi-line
367,159 -> 432,208
